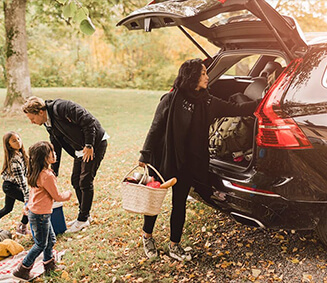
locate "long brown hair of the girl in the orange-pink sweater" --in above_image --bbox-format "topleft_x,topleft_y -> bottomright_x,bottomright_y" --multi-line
27,141 -> 54,187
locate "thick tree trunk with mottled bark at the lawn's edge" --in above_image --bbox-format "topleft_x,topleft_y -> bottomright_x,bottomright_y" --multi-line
4,0 -> 32,108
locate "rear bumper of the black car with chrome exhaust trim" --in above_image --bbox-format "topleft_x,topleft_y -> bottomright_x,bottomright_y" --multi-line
205,179 -> 327,230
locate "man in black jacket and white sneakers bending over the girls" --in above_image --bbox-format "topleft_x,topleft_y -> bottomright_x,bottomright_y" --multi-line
23,96 -> 108,232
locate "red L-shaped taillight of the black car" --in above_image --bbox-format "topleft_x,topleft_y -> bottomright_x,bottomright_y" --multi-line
254,59 -> 312,149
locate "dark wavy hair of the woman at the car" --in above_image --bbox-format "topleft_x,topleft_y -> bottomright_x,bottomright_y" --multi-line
174,58 -> 203,90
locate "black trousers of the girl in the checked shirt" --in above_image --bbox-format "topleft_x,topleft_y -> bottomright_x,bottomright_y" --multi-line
0,181 -> 28,224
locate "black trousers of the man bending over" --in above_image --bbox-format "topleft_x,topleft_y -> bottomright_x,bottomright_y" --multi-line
71,140 -> 107,221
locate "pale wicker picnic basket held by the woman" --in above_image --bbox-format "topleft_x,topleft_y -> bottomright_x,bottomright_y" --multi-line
121,164 -> 168,216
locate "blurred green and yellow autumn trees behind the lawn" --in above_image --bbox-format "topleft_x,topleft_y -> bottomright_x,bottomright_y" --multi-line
0,0 -> 327,111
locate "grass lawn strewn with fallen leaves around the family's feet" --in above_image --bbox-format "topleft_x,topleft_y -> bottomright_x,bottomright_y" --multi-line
0,88 -> 217,282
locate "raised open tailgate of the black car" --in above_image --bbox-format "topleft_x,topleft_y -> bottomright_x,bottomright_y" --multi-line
117,0 -> 307,59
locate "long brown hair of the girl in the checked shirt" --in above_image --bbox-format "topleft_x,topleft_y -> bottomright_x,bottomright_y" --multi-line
1,131 -> 28,175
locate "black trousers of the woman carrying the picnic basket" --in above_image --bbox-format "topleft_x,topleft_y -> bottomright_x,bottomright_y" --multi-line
143,170 -> 192,243
